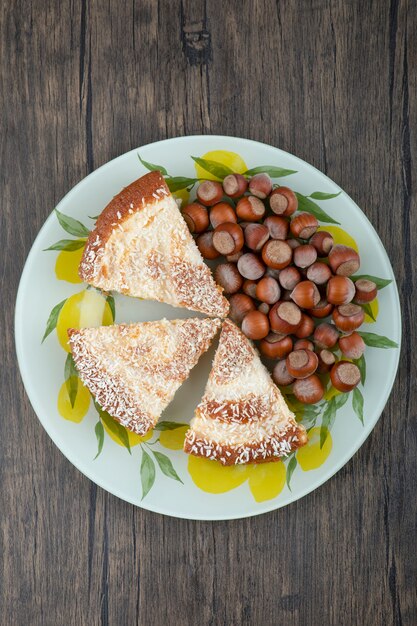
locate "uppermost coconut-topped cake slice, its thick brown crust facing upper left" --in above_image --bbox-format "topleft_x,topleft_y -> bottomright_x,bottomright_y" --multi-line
79,172 -> 229,317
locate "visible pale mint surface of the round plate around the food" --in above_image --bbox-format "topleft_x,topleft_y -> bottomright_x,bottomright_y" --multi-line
15,136 -> 401,520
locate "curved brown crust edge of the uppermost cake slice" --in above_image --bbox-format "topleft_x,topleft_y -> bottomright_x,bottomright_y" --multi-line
79,172 -> 167,282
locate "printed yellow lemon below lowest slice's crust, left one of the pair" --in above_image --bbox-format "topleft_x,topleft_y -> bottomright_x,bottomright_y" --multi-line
188,455 -> 249,493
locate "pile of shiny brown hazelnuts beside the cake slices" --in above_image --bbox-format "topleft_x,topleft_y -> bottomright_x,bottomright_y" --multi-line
182,173 -> 377,404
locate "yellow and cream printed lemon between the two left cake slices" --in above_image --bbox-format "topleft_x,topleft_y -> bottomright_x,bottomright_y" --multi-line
56,289 -> 113,352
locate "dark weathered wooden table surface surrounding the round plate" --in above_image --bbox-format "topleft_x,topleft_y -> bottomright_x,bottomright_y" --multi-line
0,0 -> 417,626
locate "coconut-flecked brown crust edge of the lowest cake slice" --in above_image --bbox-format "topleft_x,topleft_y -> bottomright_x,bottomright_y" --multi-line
184,424 -> 307,465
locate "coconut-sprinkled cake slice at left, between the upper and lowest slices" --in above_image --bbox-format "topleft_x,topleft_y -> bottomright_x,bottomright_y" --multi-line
68,318 -> 221,435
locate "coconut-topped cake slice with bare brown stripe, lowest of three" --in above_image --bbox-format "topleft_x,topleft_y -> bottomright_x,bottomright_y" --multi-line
184,320 -> 307,465
